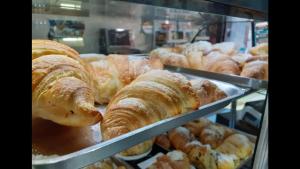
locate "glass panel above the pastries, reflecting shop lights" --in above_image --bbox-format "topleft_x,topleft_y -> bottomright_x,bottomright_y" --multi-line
32,0 -> 252,54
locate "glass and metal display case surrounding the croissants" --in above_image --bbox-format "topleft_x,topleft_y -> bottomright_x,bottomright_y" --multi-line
32,0 -> 268,169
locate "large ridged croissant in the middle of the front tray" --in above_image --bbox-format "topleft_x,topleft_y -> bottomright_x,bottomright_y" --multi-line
101,70 -> 200,156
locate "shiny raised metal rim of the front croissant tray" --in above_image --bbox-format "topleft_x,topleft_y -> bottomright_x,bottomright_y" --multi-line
32,76 -> 249,169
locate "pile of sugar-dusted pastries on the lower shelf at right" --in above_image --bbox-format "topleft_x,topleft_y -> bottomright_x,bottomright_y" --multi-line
156,119 -> 253,169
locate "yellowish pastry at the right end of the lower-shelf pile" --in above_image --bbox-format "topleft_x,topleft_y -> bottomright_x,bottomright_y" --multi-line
216,134 -> 253,159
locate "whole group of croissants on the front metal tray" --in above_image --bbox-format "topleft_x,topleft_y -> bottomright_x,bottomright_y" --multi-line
32,40 -> 230,160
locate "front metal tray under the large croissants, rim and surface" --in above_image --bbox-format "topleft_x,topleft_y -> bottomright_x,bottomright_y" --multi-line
32,74 -> 248,169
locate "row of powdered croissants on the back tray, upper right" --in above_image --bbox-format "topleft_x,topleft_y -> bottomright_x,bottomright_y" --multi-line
150,41 -> 268,80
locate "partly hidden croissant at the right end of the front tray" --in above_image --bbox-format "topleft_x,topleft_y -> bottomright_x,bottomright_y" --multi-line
190,79 -> 227,106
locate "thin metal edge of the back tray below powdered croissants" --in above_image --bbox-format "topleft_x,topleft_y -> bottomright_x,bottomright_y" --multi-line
165,65 -> 268,90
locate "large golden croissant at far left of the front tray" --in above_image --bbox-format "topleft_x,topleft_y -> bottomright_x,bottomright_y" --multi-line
32,55 -> 102,126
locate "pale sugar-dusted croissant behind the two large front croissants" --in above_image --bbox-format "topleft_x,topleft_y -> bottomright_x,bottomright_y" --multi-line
89,55 -> 163,104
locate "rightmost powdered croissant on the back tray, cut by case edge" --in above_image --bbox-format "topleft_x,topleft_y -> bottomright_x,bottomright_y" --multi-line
241,60 -> 269,80
